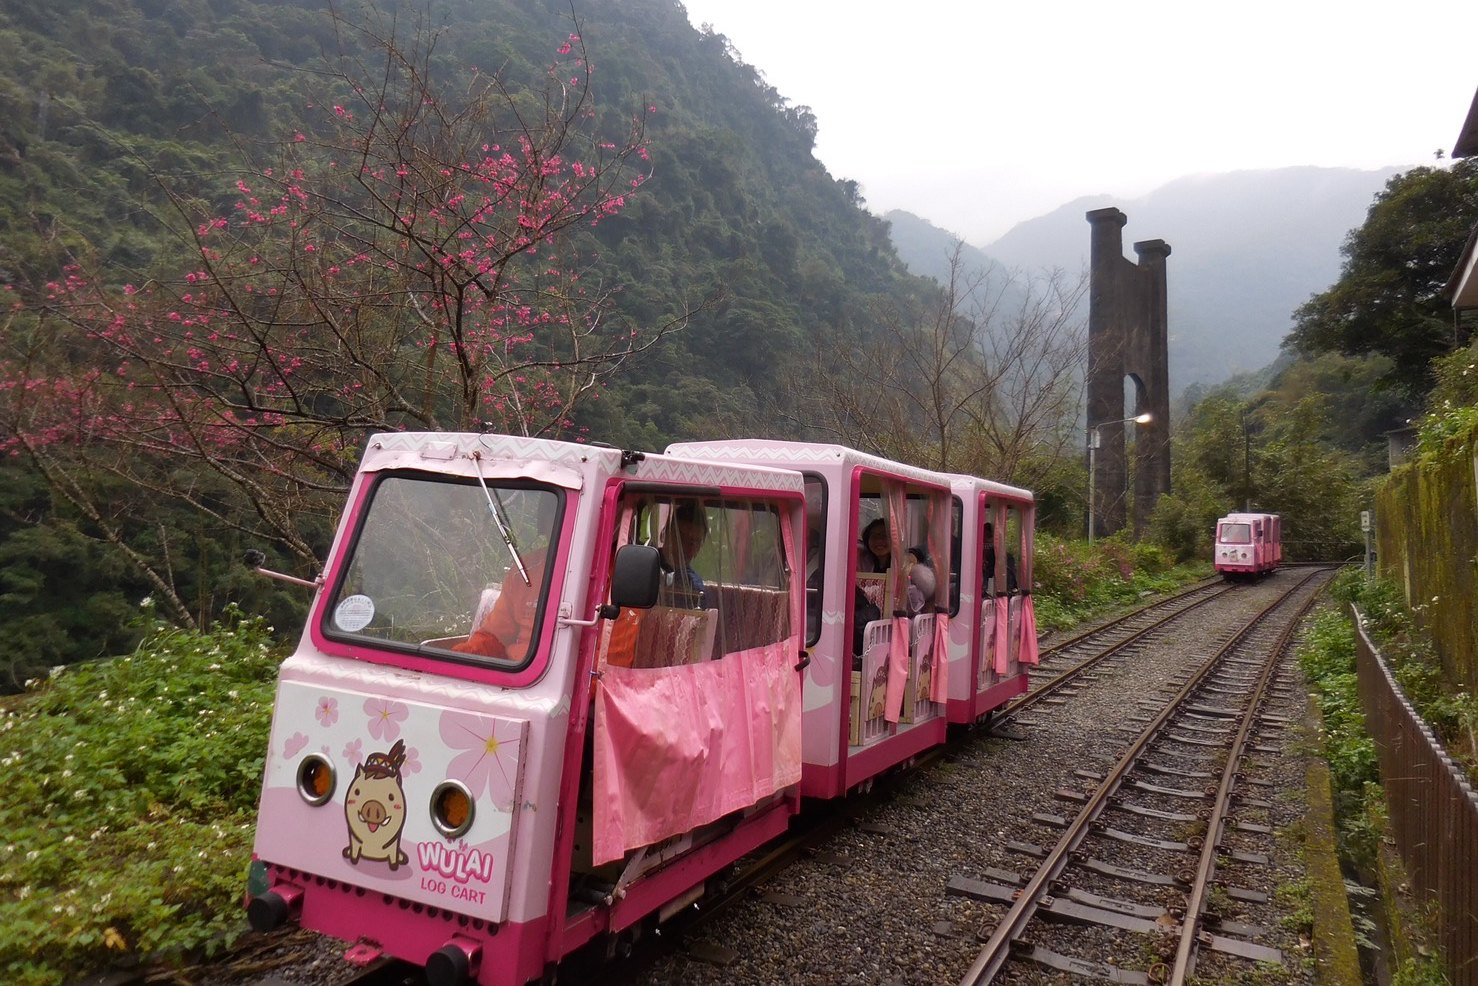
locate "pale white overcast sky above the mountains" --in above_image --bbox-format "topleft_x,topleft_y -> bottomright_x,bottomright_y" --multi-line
683,0 -> 1478,245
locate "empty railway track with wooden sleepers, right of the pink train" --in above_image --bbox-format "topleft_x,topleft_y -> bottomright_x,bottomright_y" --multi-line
949,571 -> 1323,986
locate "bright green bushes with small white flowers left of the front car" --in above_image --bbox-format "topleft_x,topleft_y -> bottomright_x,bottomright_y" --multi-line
0,612 -> 276,986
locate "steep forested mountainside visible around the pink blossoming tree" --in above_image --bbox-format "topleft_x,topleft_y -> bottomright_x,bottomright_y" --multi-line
0,0 -> 919,446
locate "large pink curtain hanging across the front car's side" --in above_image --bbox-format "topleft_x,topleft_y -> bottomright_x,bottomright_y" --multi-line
593,636 -> 801,865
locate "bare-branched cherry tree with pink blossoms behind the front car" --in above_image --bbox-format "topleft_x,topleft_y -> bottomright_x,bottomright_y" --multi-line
0,12 -> 683,609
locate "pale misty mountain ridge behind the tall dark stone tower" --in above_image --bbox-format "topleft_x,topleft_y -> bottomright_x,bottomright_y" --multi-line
885,167 -> 1401,393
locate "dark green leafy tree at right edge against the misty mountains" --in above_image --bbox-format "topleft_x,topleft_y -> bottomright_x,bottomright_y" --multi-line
1289,158 -> 1478,396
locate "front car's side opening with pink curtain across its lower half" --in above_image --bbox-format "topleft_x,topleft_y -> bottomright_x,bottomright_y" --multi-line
593,488 -> 804,865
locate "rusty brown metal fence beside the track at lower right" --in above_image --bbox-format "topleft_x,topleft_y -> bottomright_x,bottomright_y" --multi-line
1355,613 -> 1478,986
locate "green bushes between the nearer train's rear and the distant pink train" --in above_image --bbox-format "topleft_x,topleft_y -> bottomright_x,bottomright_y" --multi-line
1032,534 -> 1210,630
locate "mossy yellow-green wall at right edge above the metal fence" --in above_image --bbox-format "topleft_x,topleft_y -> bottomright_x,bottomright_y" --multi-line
1375,443 -> 1478,690
